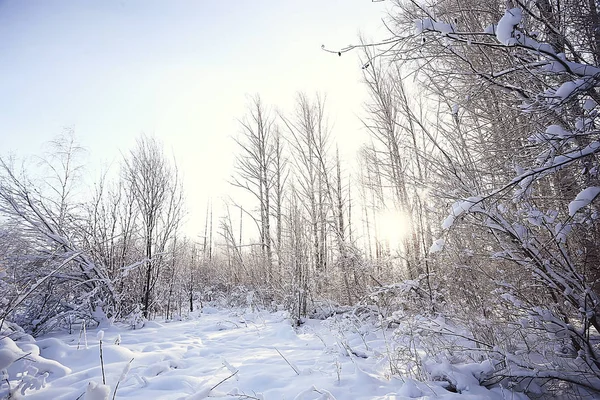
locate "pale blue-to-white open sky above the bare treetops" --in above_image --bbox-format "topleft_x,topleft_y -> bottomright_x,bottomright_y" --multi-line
0,0 -> 388,238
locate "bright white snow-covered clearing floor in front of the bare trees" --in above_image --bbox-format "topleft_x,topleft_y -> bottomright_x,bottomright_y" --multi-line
0,308 -> 525,400
